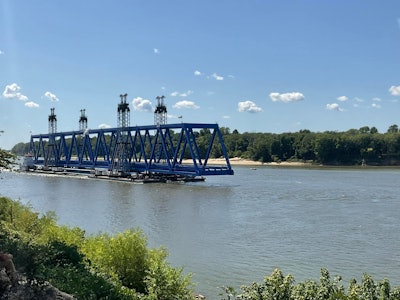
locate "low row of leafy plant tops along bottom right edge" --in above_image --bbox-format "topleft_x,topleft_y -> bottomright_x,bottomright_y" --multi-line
223,268 -> 400,300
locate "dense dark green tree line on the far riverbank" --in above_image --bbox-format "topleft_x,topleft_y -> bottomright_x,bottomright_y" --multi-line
11,125 -> 400,165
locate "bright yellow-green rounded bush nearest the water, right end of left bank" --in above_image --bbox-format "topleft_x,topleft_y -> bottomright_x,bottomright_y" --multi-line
82,230 -> 192,299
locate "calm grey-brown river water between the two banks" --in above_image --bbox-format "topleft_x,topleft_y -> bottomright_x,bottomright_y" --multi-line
0,167 -> 400,299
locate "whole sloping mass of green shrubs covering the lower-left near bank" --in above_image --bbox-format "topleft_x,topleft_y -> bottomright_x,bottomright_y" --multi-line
0,197 -> 193,299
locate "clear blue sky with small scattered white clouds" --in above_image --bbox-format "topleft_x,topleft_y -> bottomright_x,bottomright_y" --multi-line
0,0 -> 400,149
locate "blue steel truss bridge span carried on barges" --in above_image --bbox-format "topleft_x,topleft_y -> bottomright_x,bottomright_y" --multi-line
30,123 -> 234,176
